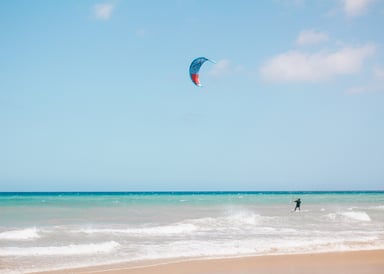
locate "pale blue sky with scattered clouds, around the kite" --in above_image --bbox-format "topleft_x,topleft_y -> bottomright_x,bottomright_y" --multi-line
0,0 -> 384,191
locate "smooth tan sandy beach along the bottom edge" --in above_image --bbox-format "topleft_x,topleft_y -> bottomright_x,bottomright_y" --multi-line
33,249 -> 384,274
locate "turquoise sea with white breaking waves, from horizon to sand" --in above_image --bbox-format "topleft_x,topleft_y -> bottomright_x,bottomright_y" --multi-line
0,192 -> 384,273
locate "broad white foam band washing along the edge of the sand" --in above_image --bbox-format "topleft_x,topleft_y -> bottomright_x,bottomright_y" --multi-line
132,236 -> 384,260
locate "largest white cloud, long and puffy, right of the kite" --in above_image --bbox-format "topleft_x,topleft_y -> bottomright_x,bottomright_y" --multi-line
260,44 -> 375,82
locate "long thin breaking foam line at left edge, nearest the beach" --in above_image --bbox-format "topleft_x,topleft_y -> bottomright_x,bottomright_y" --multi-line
0,241 -> 120,256
